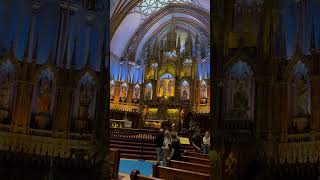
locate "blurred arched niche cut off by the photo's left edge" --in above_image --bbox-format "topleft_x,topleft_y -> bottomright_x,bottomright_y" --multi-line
0,61 -> 14,124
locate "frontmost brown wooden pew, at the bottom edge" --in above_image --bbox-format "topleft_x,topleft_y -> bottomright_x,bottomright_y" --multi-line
153,164 -> 210,180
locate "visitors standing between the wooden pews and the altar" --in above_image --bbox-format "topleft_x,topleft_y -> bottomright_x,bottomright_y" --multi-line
155,129 -> 210,165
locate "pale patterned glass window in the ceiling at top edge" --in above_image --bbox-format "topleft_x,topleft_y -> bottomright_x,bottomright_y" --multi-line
138,0 -> 193,16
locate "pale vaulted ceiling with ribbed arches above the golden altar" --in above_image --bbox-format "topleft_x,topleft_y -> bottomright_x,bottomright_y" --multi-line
110,0 -> 210,61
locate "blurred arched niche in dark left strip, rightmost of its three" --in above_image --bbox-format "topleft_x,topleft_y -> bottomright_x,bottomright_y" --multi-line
73,73 -> 96,133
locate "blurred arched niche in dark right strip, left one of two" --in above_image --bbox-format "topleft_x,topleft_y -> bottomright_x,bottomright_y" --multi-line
226,60 -> 254,120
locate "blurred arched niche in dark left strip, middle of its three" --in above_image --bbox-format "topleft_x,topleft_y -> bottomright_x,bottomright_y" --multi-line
30,69 -> 55,130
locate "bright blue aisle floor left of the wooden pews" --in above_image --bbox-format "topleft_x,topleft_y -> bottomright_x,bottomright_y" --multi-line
119,159 -> 154,176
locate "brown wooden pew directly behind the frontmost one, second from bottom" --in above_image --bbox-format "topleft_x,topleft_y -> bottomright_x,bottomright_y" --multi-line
168,160 -> 210,174
